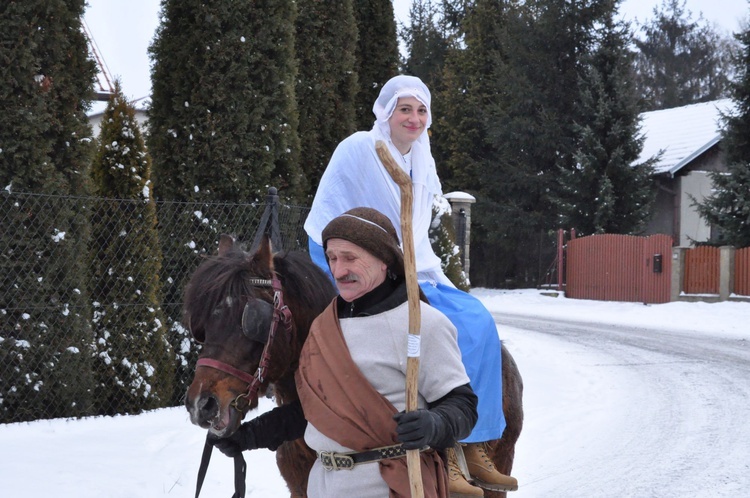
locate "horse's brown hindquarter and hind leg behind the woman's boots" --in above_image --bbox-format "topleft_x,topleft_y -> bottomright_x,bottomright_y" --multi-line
484,344 -> 523,498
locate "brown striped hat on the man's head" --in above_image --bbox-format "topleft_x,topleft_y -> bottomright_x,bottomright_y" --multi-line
323,207 -> 404,275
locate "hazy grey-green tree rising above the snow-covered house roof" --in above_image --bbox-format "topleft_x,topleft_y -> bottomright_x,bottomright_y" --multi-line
635,0 -> 735,110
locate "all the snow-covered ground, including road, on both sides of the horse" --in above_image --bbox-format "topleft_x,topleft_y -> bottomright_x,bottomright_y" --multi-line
0,289 -> 750,498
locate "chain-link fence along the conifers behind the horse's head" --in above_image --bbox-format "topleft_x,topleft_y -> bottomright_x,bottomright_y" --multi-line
0,189 -> 309,423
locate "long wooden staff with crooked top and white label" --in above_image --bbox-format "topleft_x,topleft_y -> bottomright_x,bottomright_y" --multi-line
375,140 -> 424,498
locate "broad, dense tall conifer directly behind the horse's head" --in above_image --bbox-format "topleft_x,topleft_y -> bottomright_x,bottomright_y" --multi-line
147,0 -> 307,402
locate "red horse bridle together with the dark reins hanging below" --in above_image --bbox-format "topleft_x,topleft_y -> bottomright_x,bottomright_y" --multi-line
195,276 -> 292,498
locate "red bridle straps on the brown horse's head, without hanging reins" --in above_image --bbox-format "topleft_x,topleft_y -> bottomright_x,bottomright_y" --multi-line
196,275 -> 292,411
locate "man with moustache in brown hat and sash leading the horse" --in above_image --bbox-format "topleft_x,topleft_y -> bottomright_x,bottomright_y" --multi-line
214,208 -> 477,498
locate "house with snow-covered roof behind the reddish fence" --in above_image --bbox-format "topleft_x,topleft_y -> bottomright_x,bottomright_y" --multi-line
635,99 -> 733,246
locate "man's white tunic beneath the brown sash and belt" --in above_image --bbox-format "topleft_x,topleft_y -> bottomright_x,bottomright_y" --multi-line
305,303 -> 469,498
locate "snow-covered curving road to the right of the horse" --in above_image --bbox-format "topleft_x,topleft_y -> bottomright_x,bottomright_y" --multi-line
502,313 -> 750,498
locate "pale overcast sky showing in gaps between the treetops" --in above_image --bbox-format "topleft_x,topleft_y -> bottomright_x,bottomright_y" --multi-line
85,0 -> 750,99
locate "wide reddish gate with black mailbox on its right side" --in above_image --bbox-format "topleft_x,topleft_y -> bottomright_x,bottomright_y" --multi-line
565,234 -> 672,303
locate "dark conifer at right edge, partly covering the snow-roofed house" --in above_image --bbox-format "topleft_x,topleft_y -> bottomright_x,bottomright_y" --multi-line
698,26 -> 750,248
